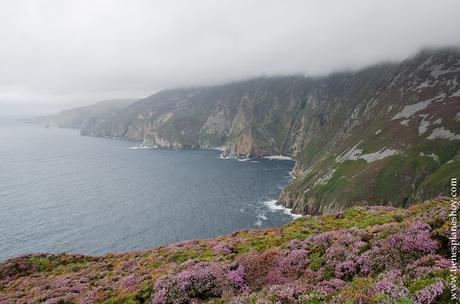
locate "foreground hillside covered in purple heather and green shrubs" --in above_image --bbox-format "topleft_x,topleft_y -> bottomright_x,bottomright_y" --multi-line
0,198 -> 458,304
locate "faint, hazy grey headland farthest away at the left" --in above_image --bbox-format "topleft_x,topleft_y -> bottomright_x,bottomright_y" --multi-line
32,99 -> 137,129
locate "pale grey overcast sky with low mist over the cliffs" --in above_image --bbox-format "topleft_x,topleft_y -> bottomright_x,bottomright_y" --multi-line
0,0 -> 460,112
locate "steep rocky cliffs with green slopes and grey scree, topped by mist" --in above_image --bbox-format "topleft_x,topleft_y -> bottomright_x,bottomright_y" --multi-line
82,49 -> 460,214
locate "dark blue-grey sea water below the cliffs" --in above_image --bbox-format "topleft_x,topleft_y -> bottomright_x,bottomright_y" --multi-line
0,122 -> 293,260
